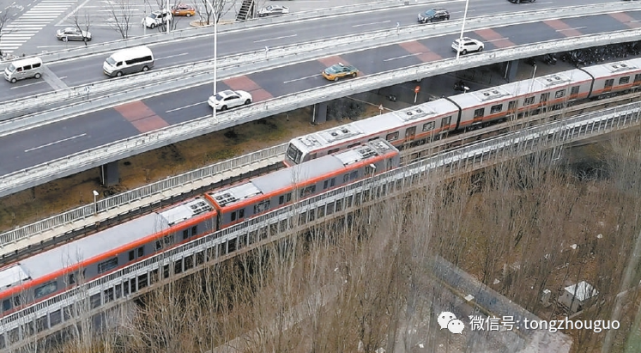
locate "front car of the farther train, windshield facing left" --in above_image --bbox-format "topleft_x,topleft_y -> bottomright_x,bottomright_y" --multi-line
285,99 -> 458,166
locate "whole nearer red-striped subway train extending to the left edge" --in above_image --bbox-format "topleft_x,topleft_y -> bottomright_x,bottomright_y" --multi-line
0,140 -> 400,316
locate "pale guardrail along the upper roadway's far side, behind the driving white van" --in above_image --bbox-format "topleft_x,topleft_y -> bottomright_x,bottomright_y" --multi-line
0,0 -> 443,71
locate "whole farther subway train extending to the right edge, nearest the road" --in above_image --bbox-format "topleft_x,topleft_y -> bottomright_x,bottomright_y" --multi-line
284,59 -> 641,166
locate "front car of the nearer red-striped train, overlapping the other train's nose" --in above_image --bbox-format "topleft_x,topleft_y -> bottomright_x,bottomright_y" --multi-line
207,140 -> 400,228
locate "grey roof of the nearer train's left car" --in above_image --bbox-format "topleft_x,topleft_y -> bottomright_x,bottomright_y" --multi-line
7,198 -> 213,288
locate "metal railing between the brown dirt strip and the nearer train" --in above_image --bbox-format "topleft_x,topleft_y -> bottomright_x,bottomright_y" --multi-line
0,144 -> 287,247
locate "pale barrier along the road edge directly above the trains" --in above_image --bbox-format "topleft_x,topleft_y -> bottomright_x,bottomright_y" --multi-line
0,29 -> 641,197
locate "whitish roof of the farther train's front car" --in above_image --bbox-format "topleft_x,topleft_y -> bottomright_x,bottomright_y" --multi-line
291,99 -> 458,152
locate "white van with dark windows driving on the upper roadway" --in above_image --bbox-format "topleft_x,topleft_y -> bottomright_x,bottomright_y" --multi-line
102,46 -> 154,77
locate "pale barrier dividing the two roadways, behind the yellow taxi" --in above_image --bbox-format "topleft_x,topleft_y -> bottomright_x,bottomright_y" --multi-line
0,3 -> 641,118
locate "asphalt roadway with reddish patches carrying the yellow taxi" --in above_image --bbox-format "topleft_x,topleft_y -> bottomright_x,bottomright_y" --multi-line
0,12 -> 641,175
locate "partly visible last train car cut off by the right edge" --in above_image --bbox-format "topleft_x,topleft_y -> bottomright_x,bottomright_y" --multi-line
581,59 -> 641,99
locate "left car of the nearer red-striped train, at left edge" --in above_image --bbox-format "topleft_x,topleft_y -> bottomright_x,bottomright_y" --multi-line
0,198 -> 217,316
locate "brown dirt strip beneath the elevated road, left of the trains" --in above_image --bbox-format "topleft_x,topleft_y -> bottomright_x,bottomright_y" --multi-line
0,104 -> 379,232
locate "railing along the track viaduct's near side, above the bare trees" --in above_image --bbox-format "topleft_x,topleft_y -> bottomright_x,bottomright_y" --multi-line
0,102 -> 641,348
